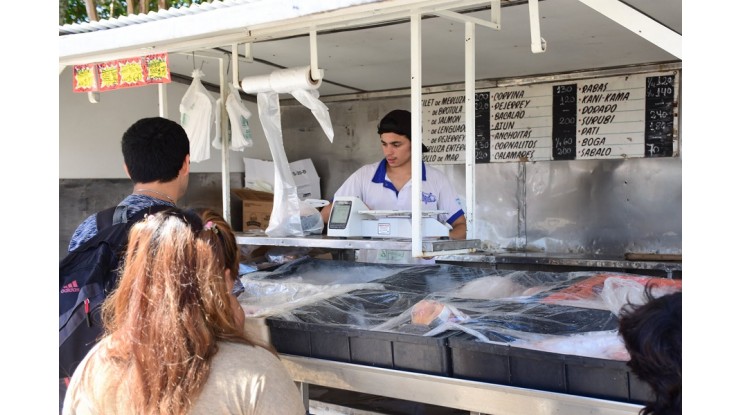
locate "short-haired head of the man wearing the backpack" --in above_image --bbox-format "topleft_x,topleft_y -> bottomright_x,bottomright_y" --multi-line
121,117 -> 190,196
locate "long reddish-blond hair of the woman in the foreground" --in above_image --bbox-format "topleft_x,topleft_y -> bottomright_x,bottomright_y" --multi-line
83,208 -> 253,414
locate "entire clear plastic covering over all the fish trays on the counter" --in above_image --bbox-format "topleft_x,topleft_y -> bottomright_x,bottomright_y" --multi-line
239,258 -> 681,360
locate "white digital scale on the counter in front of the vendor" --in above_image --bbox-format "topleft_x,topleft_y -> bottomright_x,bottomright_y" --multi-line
327,196 -> 452,239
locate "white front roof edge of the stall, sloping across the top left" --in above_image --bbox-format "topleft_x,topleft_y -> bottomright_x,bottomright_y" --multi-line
59,0 -> 490,65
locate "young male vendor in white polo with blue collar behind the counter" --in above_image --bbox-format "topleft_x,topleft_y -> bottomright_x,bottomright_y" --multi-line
321,110 -> 467,239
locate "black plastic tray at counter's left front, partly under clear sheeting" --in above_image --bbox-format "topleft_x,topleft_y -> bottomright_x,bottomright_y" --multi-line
266,289 -> 450,376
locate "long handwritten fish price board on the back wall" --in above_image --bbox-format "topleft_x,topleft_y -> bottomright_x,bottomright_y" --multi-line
422,72 -> 678,164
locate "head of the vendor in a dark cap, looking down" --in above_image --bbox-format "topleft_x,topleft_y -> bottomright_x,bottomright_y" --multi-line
378,110 -> 428,171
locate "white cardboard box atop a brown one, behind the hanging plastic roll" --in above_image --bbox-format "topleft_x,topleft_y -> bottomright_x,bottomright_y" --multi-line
244,157 -> 321,200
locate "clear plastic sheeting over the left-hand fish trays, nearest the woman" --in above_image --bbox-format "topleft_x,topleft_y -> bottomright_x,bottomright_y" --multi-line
239,257 -> 500,329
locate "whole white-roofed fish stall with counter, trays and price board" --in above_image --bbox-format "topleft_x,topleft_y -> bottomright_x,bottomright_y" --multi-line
60,0 -> 683,415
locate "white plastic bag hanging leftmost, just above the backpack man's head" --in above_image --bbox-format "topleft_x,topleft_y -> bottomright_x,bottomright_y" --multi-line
180,69 -> 216,163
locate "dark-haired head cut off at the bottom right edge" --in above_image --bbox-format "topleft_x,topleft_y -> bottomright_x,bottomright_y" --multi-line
619,286 -> 681,415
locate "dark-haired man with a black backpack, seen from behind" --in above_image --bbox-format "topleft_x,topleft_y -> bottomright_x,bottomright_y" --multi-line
59,117 -> 190,407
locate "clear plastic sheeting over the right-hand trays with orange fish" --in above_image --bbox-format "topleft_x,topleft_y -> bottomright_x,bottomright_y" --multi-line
374,271 -> 681,360
